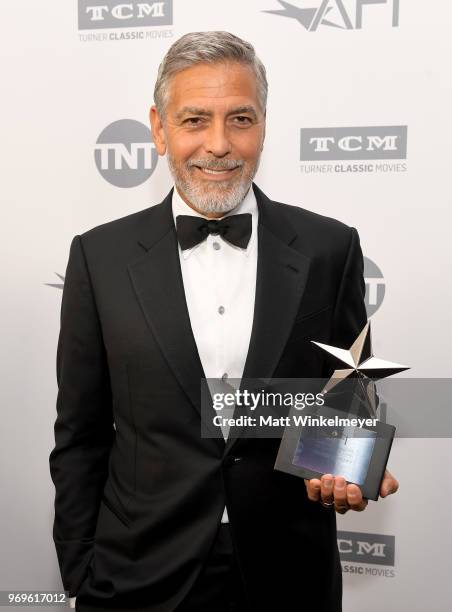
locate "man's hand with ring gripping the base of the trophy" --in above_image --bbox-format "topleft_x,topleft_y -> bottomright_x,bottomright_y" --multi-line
304,470 -> 399,514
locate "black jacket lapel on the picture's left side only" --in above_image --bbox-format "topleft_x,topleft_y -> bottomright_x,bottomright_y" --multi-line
128,190 -> 225,449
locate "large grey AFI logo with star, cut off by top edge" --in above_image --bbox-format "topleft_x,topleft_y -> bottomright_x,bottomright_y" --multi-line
263,0 -> 399,32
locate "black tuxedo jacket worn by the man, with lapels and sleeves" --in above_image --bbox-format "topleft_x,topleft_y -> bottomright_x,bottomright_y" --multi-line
50,185 -> 366,612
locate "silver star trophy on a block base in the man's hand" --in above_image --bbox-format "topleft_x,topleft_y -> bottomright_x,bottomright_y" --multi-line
275,322 -> 409,500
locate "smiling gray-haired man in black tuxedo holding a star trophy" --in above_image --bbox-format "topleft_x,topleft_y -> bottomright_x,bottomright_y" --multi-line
50,32 -> 398,612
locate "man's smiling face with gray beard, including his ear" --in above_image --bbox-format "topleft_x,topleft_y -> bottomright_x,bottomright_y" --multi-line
150,62 -> 265,217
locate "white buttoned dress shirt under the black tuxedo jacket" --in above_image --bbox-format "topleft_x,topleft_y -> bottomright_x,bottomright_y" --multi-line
172,187 -> 258,522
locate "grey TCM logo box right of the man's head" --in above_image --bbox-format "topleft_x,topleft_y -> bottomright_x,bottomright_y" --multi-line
300,125 -> 408,161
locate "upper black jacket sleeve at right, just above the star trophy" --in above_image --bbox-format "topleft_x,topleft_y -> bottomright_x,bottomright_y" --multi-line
331,227 -> 367,348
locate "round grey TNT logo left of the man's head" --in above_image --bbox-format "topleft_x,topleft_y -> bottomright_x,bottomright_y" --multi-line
94,119 -> 158,187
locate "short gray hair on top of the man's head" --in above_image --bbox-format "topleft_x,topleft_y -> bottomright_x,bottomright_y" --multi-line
154,31 -> 268,117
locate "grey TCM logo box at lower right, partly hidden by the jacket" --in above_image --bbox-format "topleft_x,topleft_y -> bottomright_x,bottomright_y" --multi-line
337,531 -> 395,565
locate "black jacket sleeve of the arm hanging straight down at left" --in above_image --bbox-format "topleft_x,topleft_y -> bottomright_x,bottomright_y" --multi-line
49,236 -> 115,596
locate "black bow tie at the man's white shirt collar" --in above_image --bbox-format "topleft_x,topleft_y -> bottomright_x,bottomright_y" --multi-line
176,213 -> 251,251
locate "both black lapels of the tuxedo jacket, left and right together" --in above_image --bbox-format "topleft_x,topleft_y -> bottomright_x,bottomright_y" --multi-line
128,183 -> 310,454
